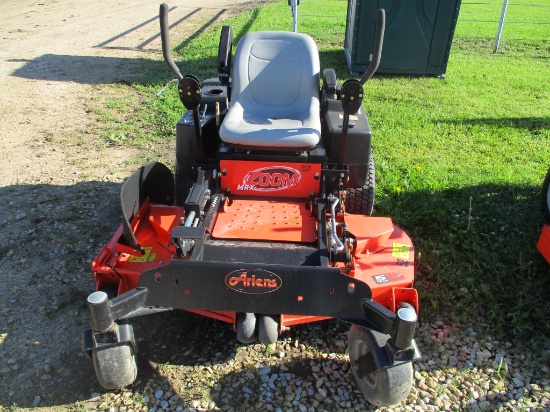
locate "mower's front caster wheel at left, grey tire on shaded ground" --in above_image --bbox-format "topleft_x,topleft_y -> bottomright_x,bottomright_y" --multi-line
92,343 -> 137,389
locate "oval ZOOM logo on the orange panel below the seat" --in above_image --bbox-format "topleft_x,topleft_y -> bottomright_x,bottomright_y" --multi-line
237,166 -> 302,192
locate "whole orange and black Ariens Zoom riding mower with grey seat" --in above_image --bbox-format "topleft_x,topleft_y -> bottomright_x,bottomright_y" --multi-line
83,4 -> 419,405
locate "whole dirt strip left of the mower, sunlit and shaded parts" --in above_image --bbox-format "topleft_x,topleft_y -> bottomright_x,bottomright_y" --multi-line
0,0 -> 252,410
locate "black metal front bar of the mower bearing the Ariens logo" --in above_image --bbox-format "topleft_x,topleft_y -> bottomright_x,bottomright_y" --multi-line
139,260 -> 371,317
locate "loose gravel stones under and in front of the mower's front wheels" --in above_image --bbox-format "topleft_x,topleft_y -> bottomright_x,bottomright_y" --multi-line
57,314 -> 550,412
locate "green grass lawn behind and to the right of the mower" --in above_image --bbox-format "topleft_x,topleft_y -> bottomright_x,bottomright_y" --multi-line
99,0 -> 550,337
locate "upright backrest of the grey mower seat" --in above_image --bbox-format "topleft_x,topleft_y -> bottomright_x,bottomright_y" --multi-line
231,32 -> 319,117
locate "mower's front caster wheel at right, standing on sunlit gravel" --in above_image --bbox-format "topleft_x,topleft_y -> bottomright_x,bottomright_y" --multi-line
348,325 -> 413,406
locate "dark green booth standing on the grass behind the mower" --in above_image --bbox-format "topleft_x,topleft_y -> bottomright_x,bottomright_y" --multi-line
344,0 -> 461,77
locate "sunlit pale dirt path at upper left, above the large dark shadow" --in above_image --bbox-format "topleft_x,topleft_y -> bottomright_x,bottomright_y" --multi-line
0,0 -> 254,186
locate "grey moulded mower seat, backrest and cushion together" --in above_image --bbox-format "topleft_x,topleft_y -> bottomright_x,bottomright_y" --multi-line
220,32 -> 321,151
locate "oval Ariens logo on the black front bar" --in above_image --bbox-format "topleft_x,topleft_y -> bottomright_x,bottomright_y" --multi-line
225,269 -> 283,295
